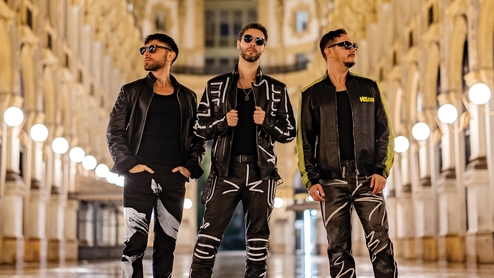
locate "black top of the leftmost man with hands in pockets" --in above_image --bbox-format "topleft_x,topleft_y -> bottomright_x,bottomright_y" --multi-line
138,91 -> 182,166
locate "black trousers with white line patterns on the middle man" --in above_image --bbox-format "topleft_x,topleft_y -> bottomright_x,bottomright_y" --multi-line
190,163 -> 276,278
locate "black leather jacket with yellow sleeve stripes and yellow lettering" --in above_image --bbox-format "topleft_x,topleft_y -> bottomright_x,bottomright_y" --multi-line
297,73 -> 394,188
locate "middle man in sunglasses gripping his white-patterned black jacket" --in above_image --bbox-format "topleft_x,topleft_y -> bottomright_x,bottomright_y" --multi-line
190,23 -> 296,278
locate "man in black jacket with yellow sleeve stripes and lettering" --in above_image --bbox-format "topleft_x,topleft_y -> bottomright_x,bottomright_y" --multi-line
297,29 -> 398,278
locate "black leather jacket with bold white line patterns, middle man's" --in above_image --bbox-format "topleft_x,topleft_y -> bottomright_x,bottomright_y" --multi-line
194,67 -> 296,181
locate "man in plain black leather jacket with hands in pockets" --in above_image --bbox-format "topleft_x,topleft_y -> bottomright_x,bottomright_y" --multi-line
106,34 -> 205,278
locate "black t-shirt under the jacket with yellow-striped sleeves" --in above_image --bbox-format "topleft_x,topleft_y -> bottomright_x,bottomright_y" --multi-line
336,90 -> 355,160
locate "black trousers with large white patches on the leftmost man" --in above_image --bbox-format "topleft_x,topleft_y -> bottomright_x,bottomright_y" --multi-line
122,166 -> 186,278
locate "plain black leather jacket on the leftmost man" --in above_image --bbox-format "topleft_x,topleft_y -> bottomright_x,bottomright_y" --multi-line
106,73 -> 205,178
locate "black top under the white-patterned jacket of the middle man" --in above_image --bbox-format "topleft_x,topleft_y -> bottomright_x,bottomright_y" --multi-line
232,88 -> 257,155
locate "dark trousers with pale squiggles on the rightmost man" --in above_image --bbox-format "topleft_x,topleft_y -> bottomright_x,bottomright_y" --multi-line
320,164 -> 398,278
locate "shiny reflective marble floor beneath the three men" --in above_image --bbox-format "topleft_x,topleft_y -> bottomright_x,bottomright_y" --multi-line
0,251 -> 494,278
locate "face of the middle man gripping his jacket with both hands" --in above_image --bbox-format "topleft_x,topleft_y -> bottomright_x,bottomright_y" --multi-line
237,29 -> 266,63
